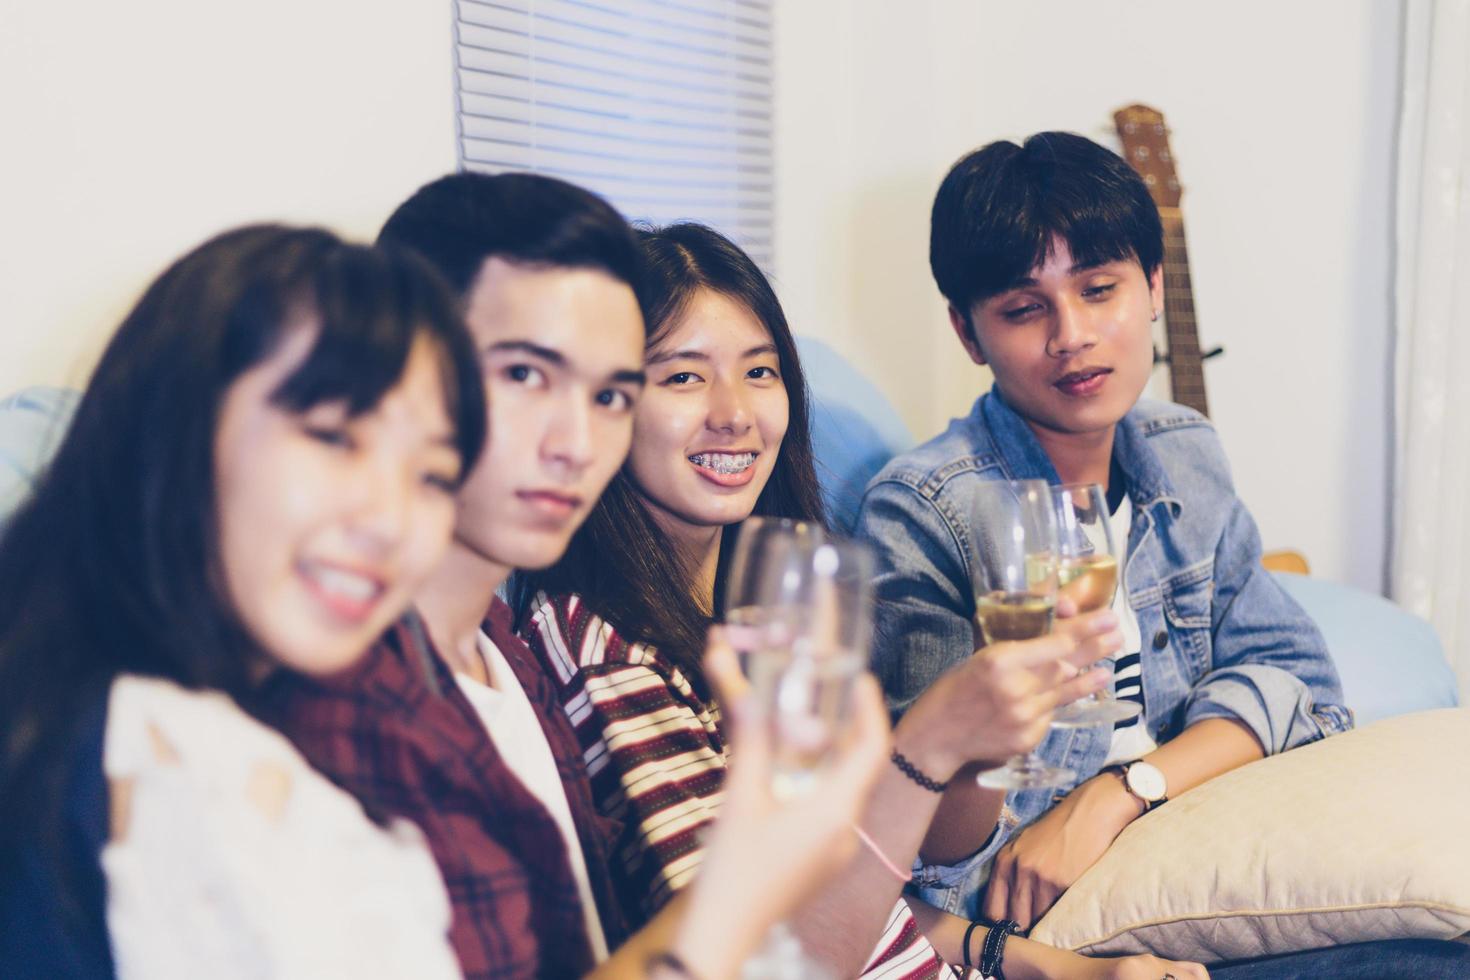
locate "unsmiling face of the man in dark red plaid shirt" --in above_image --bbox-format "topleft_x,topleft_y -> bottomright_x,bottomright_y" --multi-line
456,259 -> 644,572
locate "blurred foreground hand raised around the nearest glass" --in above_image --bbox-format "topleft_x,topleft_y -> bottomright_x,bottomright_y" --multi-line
675,627 -> 889,977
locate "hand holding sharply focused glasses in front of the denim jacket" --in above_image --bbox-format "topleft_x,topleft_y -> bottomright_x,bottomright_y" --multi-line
895,610 -> 1123,782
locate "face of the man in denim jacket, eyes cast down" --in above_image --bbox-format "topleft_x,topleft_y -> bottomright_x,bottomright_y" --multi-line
950,239 -> 1163,435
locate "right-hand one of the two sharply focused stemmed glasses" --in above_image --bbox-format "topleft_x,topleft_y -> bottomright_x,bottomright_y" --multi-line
1051,483 -> 1142,726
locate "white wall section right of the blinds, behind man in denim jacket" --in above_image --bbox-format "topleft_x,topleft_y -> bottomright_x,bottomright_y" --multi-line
776,0 -> 1401,591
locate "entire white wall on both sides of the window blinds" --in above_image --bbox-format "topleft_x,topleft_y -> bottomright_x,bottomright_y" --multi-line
0,0 -> 1399,589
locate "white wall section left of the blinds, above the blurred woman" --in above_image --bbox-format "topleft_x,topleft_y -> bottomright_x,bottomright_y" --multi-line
0,0 -> 454,392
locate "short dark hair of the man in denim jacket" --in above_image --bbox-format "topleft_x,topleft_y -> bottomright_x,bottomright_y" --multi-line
929,132 -> 1164,332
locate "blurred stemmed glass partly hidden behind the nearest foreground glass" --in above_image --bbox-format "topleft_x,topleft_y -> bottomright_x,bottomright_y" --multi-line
723,517 -> 826,677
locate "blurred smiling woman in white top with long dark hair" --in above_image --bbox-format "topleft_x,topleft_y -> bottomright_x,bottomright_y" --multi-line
0,226 -> 485,977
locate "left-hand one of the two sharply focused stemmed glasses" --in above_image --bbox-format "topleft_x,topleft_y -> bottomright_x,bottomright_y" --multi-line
970,480 -> 1076,789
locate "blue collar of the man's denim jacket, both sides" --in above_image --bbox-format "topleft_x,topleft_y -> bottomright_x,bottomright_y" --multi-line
975,385 -> 1183,517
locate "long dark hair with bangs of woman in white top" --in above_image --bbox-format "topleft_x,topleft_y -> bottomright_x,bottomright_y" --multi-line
0,226 -> 485,892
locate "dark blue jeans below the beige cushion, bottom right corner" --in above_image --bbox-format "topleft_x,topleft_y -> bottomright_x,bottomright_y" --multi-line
1210,939 -> 1470,980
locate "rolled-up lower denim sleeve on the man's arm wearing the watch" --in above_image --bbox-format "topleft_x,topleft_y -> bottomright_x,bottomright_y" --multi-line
1183,500 -> 1352,755
